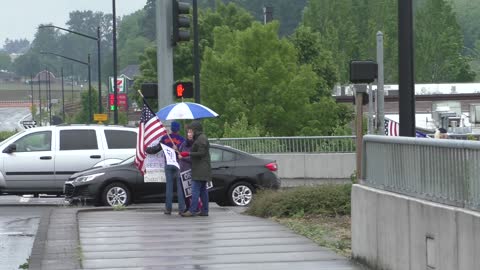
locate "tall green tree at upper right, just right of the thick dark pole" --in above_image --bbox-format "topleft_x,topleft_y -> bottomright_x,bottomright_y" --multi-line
415,0 -> 475,83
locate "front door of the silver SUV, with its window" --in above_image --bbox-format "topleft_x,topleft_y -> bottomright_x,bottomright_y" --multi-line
2,130 -> 55,191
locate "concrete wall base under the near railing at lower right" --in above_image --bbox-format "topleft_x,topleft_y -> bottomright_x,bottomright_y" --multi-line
352,185 -> 480,270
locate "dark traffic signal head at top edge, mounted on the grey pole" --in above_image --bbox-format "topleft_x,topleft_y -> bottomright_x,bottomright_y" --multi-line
172,0 -> 190,46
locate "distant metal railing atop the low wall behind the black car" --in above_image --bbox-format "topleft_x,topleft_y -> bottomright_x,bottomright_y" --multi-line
209,136 -> 355,154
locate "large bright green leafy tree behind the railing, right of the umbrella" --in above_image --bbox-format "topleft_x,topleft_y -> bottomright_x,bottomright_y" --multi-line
201,23 -> 348,137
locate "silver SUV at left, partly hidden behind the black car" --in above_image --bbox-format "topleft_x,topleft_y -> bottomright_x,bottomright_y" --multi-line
0,125 -> 138,195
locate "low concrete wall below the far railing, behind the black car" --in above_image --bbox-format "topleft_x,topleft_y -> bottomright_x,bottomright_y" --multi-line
255,153 -> 355,181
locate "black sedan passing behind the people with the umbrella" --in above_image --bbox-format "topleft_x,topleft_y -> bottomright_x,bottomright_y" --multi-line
64,144 -> 280,206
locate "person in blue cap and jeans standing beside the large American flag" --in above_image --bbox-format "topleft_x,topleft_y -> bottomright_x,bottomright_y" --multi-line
145,122 -> 185,215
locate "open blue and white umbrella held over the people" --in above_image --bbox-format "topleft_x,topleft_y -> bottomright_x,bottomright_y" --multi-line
157,102 -> 218,120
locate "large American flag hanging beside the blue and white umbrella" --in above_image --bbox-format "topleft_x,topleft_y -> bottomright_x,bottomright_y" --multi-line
135,100 -> 167,174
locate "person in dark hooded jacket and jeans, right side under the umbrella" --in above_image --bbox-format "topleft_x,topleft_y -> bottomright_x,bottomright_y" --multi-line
180,121 -> 212,217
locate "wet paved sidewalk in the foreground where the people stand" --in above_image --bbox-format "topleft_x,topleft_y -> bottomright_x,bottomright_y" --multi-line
30,206 -> 368,270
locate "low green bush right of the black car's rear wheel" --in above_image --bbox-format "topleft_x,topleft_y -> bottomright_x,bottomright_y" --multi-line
246,184 -> 352,217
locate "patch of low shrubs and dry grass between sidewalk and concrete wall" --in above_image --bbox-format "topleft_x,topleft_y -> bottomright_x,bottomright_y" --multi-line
246,184 -> 351,257
